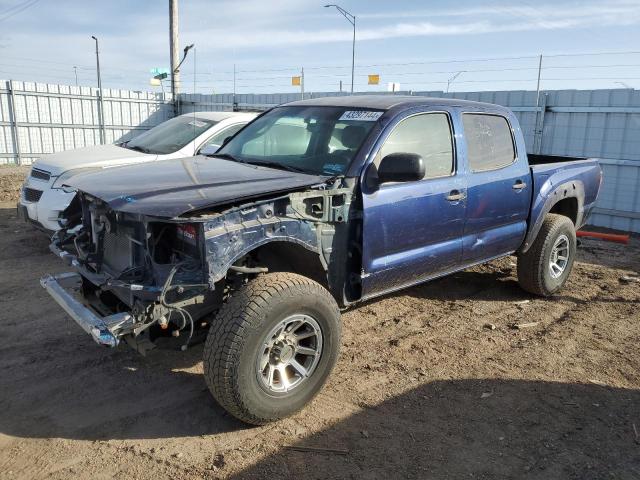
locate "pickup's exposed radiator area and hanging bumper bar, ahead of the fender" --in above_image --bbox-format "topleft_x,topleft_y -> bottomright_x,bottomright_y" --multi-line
41,193 -> 215,351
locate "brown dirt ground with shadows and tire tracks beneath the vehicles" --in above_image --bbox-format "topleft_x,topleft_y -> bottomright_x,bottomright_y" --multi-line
0,170 -> 640,480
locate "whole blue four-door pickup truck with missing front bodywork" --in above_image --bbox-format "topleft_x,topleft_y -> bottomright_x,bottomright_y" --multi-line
41,96 -> 602,424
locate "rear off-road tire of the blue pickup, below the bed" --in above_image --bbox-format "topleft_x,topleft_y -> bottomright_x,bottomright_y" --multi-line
518,213 -> 576,297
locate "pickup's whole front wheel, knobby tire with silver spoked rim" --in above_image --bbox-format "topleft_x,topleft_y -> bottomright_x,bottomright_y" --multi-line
204,273 -> 341,425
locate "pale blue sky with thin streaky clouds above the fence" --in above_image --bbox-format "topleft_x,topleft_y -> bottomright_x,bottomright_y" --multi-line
0,0 -> 640,93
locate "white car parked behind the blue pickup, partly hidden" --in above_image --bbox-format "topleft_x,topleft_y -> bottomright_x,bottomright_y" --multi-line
18,112 -> 257,232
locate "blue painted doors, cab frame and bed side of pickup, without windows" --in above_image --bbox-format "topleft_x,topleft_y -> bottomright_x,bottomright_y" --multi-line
344,101 -> 601,298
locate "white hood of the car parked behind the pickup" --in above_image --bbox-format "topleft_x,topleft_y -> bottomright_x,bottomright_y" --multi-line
34,145 -> 151,176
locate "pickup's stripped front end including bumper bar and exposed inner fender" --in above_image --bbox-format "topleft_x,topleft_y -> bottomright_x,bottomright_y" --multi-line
41,183 -> 353,354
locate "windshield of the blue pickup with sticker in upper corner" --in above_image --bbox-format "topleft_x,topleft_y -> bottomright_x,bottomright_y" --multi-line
218,106 -> 383,176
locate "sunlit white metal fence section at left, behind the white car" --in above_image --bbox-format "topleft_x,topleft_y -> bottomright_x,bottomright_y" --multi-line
0,81 -> 173,165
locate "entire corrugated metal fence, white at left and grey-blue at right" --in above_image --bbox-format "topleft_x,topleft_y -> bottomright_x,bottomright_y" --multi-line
0,82 -> 640,232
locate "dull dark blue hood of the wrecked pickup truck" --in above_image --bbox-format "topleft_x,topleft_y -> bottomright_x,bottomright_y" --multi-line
68,156 -> 326,218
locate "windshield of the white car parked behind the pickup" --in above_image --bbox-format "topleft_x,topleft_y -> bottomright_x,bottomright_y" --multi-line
123,116 -> 218,154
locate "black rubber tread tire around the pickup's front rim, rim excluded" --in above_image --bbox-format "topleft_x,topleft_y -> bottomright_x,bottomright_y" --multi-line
204,272 -> 341,425
